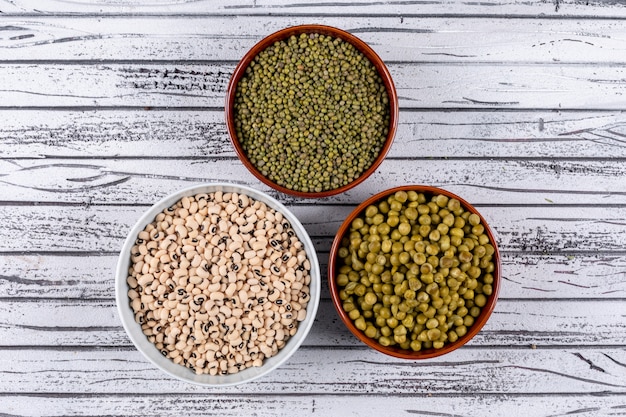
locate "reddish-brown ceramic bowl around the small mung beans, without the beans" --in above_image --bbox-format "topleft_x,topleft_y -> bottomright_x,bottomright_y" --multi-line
226,25 -> 398,198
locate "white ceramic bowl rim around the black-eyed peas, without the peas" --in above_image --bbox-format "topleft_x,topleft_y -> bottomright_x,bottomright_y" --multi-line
115,183 -> 321,387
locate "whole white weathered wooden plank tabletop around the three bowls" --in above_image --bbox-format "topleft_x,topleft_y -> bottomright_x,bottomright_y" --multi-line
0,0 -> 626,417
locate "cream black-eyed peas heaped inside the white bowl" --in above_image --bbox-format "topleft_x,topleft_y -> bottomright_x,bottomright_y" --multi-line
127,192 -> 311,375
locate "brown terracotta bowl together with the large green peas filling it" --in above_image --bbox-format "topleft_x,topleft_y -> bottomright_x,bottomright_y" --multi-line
328,185 -> 501,359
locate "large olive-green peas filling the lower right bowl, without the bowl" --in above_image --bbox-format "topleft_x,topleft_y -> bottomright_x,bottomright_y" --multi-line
337,193 -> 495,349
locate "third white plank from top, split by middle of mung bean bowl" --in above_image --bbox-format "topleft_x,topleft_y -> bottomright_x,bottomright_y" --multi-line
0,63 -> 626,110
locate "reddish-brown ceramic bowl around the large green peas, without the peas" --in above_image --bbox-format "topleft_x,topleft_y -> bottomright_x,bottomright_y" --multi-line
328,185 -> 501,359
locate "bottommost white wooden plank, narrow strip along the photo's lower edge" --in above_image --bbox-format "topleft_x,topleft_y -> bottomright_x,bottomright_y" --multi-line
0,392 -> 626,417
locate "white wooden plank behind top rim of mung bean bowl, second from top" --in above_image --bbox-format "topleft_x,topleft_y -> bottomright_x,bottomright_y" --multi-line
0,14 -> 626,64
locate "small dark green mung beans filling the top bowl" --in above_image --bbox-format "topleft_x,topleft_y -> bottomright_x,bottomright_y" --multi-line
234,33 -> 390,193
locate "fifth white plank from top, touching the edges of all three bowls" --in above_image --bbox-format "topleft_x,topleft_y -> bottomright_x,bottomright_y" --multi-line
0,157 -> 626,205
